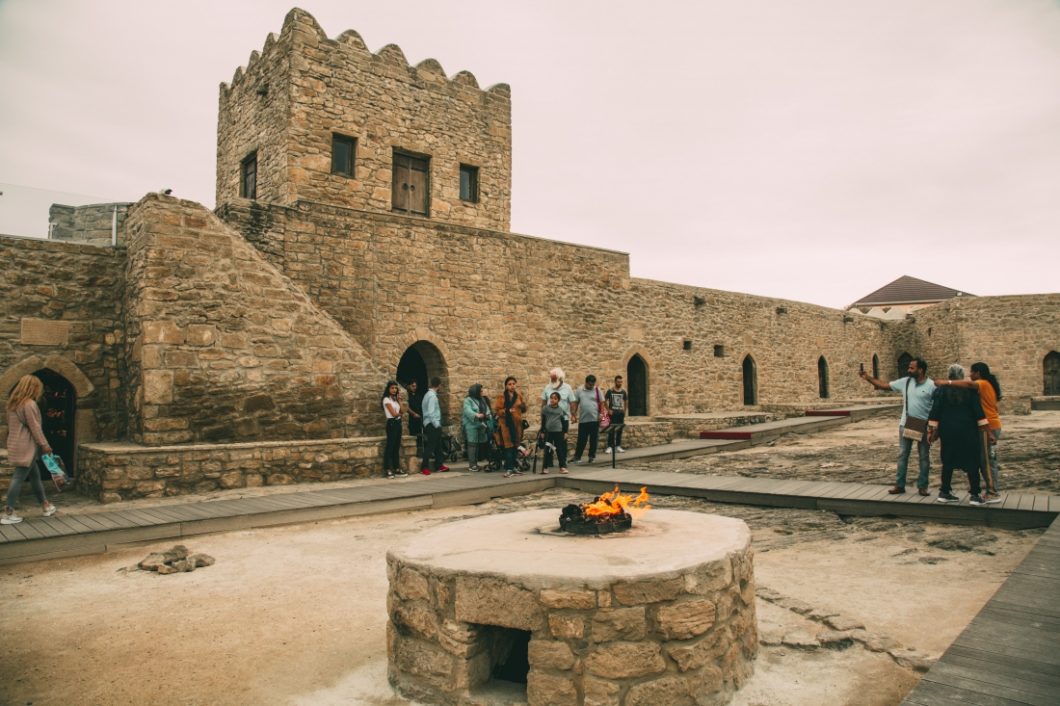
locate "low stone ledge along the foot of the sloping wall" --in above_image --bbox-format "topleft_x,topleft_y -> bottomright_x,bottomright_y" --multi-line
77,437 -> 419,502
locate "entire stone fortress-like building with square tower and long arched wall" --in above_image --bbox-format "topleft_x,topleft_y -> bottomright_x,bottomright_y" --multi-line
0,10 -> 1060,501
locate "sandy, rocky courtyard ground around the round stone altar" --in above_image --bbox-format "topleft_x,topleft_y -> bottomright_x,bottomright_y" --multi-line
0,412 -> 1060,706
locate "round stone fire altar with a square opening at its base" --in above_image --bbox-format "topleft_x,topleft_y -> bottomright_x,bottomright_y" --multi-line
387,510 -> 758,706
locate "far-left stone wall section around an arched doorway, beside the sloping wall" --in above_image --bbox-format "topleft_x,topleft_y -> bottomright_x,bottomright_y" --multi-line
0,236 -> 125,441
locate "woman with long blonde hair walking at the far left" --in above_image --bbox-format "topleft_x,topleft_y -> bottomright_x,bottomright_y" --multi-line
0,375 -> 55,525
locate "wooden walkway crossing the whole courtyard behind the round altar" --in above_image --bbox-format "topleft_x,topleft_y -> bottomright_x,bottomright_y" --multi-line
0,463 -> 1060,564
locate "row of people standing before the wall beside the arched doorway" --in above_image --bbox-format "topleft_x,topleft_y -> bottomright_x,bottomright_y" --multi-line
381,368 -> 629,478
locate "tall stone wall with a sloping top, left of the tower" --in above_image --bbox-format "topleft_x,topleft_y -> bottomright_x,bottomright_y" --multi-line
125,194 -> 386,445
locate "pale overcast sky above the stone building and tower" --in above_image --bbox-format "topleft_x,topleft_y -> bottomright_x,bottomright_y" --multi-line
0,0 -> 1060,306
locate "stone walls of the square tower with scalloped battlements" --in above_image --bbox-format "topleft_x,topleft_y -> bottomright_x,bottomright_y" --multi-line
217,10 -> 512,230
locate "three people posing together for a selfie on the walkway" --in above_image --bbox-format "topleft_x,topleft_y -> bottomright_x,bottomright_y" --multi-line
860,358 -> 1002,505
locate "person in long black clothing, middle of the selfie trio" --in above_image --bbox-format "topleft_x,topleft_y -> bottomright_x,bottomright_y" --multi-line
928,364 -> 987,505
